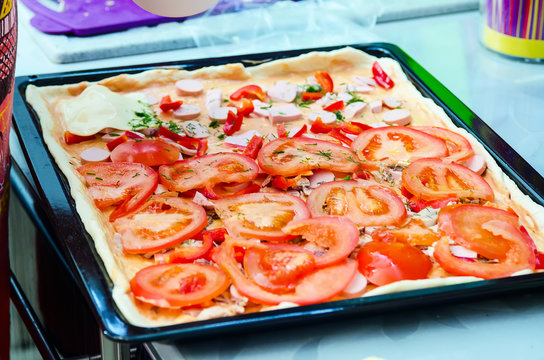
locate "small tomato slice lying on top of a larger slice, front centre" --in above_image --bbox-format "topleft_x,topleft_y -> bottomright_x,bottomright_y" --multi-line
244,244 -> 315,292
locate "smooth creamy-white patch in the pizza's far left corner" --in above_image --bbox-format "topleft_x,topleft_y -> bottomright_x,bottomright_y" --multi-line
60,85 -> 146,136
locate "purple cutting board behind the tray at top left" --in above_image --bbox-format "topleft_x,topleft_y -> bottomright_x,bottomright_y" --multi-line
21,0 -> 276,36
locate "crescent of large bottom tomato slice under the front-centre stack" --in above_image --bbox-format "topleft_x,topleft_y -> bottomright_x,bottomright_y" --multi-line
213,238 -> 357,305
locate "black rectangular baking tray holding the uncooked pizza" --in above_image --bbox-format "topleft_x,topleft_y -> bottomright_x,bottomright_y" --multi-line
13,43 -> 544,342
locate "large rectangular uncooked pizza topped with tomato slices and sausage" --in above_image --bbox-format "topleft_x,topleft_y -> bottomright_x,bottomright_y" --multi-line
26,48 -> 544,326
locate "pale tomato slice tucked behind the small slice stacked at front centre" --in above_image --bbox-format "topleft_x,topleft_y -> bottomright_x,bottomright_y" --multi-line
282,217 -> 359,268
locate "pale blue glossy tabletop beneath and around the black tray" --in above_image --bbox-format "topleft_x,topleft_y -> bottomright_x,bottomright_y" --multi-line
12,8 -> 544,359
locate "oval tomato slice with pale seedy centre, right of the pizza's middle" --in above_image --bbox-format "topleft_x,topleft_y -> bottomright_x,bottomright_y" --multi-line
307,180 -> 407,226
